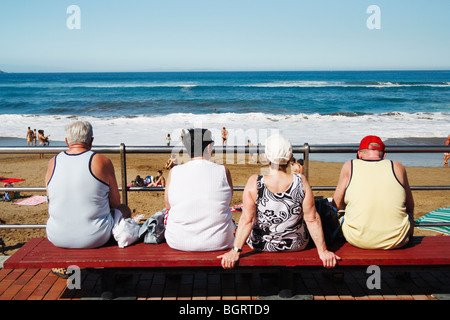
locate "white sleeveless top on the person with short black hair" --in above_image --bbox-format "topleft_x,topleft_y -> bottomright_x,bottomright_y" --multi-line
165,160 -> 235,251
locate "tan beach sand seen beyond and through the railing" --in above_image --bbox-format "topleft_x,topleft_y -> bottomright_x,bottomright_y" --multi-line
0,154 -> 450,255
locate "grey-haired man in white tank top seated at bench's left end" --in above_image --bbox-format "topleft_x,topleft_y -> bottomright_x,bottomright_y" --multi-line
45,121 -> 131,249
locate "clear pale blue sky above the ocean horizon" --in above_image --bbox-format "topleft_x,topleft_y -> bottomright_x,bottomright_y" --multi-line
0,0 -> 450,72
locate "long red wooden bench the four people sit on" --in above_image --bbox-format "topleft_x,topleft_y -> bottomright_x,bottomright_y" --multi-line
4,236 -> 450,298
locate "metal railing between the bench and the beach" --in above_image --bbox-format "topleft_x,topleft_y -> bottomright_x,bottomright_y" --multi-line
0,143 -> 450,229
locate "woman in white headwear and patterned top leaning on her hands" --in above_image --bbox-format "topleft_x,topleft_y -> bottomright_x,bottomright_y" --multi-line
218,135 -> 340,269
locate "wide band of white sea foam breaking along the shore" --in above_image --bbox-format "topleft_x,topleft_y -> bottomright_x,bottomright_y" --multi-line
0,112 -> 450,145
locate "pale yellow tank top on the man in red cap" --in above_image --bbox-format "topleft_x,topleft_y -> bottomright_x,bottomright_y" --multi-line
342,160 -> 411,249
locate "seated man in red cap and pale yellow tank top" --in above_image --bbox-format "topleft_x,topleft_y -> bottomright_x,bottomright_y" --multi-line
333,136 -> 414,249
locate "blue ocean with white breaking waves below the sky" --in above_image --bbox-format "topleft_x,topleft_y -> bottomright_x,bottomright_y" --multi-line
0,71 -> 450,166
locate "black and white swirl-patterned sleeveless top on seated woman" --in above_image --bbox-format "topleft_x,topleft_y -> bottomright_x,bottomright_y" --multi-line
247,174 -> 309,252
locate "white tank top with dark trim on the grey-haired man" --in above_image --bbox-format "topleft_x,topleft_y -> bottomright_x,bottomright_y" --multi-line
47,151 -> 114,248
